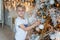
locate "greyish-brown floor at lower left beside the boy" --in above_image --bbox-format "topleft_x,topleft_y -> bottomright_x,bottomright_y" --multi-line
0,25 -> 14,40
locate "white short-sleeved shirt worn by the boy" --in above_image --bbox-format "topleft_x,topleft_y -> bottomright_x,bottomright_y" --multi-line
15,17 -> 28,40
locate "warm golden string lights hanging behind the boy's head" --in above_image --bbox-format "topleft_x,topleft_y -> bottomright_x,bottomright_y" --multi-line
4,0 -> 34,12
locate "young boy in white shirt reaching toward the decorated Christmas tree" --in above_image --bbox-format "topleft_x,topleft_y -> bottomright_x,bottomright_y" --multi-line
15,5 -> 40,40
